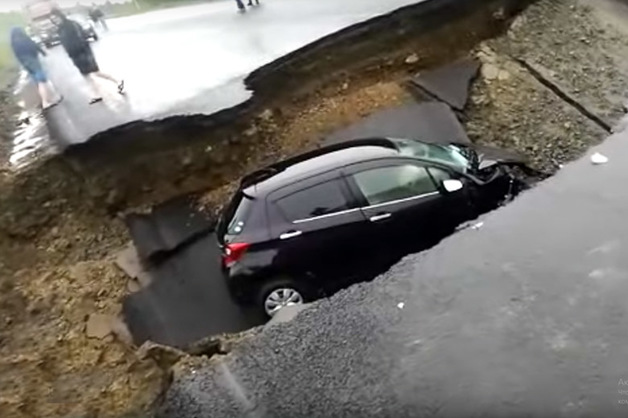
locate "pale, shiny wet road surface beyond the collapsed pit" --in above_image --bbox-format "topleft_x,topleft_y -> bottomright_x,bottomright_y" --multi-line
11,0 -> 426,163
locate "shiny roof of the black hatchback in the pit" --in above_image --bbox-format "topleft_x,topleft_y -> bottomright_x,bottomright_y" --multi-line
244,145 -> 399,196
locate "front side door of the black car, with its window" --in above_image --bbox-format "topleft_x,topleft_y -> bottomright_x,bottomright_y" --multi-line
346,160 -> 458,261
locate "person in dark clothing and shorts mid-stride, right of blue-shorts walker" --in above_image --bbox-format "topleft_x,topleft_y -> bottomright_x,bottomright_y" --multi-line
50,10 -> 124,104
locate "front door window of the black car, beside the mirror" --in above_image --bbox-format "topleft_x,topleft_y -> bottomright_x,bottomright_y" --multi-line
353,164 -> 437,205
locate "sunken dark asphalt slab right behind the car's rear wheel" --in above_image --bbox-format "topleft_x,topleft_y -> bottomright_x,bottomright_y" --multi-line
123,233 -> 266,348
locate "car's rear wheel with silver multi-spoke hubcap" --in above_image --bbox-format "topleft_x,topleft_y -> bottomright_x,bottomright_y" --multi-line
257,278 -> 309,318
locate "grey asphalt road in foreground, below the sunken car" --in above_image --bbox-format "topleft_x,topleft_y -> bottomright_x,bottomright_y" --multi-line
161,126 -> 628,418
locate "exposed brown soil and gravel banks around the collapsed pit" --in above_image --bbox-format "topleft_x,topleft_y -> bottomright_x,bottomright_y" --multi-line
0,0 -> 626,417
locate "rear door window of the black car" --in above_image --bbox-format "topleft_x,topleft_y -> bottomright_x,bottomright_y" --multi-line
275,180 -> 350,222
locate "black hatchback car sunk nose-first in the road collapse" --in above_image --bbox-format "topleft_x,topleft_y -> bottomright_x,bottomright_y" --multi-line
217,139 -> 525,316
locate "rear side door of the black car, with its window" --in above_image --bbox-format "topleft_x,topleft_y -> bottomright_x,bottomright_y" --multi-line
268,172 -> 369,290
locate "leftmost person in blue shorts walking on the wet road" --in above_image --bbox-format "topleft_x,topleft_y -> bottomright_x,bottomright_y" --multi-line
11,27 -> 63,110
